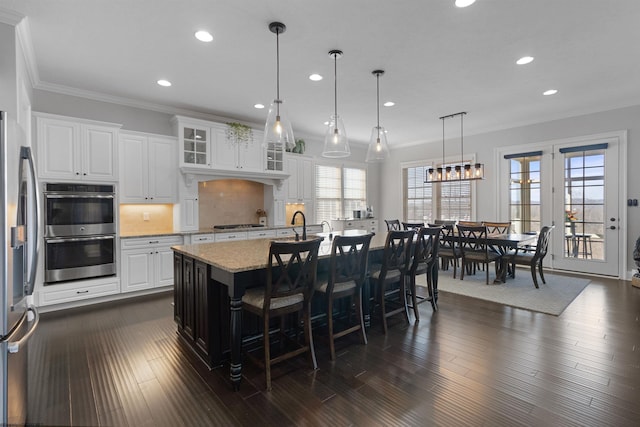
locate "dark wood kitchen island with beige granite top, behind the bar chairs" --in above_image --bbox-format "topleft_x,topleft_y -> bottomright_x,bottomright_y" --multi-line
172,230 -> 386,390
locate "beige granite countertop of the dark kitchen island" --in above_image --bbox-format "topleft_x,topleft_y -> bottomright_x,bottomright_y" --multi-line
172,230 -> 387,273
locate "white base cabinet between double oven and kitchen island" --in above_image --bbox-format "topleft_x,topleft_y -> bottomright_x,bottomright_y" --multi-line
121,235 -> 183,293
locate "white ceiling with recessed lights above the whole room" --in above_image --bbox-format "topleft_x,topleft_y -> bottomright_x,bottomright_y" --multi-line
0,0 -> 640,147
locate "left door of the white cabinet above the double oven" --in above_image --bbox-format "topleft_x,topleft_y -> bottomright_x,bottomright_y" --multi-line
37,118 -> 81,179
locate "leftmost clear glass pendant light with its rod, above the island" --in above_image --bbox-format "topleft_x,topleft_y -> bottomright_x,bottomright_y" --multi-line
263,22 -> 296,150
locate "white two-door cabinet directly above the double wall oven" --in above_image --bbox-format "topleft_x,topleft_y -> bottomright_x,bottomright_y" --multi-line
34,113 -> 120,181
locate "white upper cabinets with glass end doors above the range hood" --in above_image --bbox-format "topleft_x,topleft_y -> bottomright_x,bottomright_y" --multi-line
172,116 -> 286,179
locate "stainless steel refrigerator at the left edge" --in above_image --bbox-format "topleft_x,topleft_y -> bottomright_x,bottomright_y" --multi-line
0,111 -> 40,425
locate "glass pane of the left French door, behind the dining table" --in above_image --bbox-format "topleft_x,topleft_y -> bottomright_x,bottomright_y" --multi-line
505,151 -> 542,233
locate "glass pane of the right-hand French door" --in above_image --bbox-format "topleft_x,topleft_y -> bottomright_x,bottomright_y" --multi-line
564,150 -> 605,260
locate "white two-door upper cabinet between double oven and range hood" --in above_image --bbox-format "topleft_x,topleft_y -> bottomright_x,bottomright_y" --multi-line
120,132 -> 178,203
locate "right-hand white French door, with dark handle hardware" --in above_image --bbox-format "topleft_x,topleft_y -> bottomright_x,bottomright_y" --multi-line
552,137 -> 621,276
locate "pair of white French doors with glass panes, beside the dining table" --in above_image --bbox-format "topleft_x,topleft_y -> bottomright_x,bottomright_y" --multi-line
497,132 -> 626,277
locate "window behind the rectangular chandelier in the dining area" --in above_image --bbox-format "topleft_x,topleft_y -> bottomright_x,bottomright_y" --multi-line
403,164 -> 471,223
